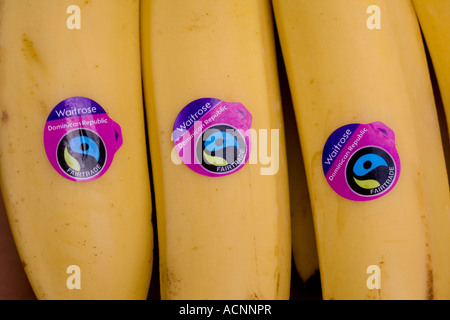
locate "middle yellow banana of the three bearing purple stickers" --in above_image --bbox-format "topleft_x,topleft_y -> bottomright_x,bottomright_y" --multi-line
141,0 -> 291,299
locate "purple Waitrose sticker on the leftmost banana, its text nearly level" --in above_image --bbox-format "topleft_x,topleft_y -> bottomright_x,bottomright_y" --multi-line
44,97 -> 123,182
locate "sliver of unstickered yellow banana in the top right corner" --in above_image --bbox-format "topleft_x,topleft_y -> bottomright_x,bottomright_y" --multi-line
413,0 -> 450,139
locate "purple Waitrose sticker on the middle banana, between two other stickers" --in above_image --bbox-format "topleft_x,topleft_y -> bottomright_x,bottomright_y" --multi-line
172,98 -> 252,177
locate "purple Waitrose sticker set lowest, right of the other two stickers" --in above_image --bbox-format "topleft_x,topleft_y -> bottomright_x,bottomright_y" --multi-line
322,122 -> 400,201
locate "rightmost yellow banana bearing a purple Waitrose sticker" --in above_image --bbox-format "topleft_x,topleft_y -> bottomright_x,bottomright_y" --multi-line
273,0 -> 450,299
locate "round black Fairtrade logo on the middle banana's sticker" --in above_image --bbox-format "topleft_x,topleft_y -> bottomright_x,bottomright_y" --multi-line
196,124 -> 247,174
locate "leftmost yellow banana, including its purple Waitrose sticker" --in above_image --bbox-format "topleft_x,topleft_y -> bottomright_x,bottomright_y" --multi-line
0,0 -> 153,299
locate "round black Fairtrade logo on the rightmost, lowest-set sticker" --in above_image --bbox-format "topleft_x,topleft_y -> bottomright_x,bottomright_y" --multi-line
346,146 -> 397,197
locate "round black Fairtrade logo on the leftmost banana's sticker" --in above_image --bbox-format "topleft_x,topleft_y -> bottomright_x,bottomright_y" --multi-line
57,129 -> 106,179
